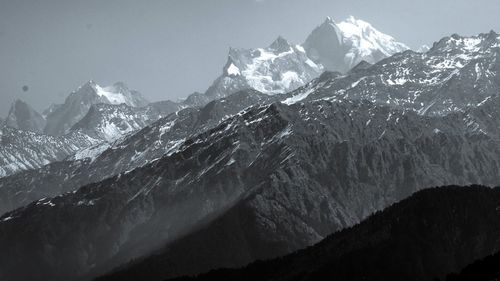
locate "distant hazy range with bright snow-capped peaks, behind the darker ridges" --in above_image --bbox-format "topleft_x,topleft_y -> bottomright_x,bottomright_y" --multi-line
0,17 -> 407,176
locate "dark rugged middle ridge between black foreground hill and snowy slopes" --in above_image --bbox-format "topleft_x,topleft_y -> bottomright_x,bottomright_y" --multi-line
0,92 -> 500,280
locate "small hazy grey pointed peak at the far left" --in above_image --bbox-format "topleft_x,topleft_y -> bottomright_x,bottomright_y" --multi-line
3,99 -> 45,133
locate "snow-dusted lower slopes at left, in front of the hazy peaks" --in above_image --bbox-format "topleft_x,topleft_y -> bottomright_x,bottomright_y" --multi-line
0,99 -> 180,179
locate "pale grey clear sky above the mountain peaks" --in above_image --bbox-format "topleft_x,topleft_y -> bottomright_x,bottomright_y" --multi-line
0,0 -> 500,117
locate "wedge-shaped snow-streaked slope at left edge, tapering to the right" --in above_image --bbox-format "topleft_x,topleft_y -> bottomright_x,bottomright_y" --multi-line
0,127 -> 100,177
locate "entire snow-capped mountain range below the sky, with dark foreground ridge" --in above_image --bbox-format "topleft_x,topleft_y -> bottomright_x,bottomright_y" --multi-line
0,17 -> 500,281
